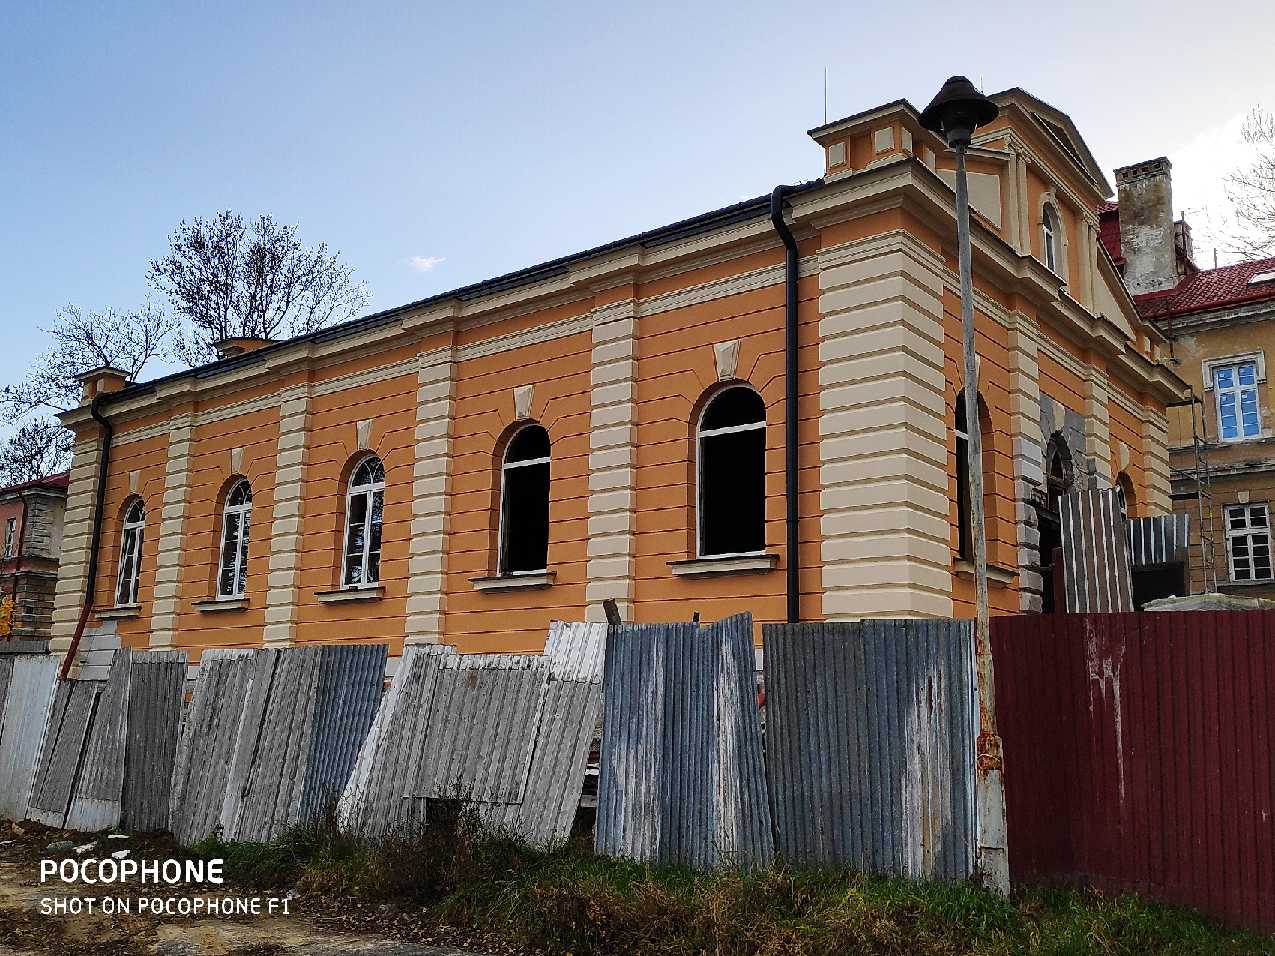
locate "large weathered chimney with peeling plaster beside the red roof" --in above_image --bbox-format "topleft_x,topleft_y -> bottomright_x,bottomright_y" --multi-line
1116,156 -> 1178,296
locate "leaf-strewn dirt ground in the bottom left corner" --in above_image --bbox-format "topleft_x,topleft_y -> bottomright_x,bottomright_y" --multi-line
0,821 -> 510,956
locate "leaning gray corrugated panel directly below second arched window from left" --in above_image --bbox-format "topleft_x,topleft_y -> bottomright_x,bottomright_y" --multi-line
170,650 -> 259,844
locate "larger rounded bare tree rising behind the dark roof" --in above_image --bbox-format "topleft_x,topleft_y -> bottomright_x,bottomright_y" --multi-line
147,210 -> 368,366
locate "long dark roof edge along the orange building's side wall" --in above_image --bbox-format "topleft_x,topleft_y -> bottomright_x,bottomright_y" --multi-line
96,178 -> 824,404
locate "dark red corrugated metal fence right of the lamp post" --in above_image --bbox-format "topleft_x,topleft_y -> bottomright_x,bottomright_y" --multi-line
992,611 -> 1275,931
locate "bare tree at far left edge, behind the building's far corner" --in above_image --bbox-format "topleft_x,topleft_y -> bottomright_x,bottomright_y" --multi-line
0,302 -> 173,483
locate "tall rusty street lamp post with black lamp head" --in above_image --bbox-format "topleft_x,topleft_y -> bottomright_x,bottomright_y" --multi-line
921,76 -> 1010,894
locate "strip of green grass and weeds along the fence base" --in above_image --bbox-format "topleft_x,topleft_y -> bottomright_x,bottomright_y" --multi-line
196,809 -> 1275,956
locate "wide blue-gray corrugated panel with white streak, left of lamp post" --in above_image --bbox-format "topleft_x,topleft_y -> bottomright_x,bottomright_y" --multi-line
762,621 -> 977,880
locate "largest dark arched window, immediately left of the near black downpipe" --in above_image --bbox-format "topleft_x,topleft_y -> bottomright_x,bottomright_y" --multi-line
696,385 -> 766,557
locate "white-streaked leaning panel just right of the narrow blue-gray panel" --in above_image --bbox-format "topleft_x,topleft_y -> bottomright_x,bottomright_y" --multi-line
338,644 -> 455,836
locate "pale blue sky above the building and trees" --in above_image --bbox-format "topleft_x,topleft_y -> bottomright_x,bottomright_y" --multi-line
0,0 -> 1275,395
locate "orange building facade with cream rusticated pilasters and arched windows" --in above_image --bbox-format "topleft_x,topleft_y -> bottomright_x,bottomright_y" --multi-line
54,91 -> 1182,658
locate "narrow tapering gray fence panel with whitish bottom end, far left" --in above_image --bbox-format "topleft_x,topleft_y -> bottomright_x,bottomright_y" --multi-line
66,648 -> 133,832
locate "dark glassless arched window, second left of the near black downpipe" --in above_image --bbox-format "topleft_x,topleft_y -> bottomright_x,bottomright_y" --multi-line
497,422 -> 550,575
